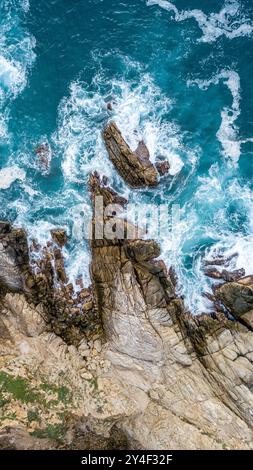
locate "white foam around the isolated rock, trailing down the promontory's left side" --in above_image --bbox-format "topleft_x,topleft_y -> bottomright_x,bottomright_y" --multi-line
52,59 -> 189,288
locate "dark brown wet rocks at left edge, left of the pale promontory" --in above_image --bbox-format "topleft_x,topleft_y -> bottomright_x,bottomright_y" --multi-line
0,222 -> 98,343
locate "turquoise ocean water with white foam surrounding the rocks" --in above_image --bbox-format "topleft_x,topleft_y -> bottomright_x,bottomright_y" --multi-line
0,0 -> 253,314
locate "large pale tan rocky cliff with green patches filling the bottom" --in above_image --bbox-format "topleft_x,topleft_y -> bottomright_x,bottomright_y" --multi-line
0,175 -> 253,449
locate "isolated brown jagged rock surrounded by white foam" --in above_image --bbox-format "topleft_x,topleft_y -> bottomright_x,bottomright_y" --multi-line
103,122 -> 158,188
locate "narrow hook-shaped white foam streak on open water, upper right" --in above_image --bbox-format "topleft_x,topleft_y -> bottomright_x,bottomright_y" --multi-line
188,70 -> 242,164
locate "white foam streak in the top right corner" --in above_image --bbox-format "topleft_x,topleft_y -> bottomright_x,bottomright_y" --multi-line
147,0 -> 253,42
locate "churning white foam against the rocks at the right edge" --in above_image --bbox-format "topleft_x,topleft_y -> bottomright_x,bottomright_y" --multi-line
155,157 -> 253,314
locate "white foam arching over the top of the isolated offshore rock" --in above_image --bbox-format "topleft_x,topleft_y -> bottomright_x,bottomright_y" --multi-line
54,74 -> 184,183
